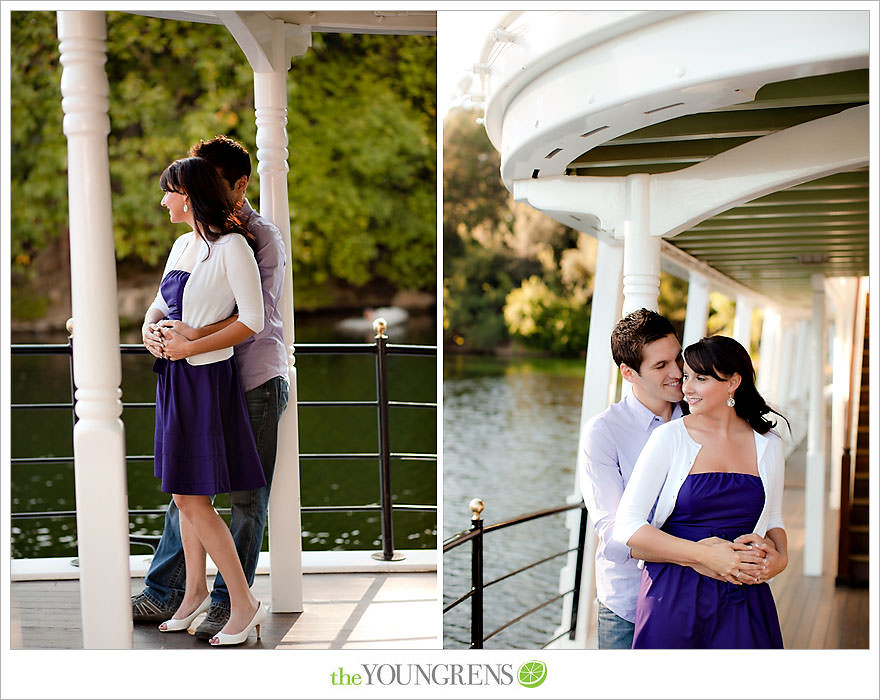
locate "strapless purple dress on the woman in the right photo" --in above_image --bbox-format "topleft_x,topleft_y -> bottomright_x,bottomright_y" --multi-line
633,472 -> 782,649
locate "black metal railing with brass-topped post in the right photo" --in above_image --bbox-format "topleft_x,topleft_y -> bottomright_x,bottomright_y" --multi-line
443,498 -> 587,649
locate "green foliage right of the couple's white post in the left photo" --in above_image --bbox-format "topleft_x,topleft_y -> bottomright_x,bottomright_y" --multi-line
288,34 -> 437,304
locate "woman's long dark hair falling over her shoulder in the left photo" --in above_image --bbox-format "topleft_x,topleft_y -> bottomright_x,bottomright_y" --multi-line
159,158 -> 256,255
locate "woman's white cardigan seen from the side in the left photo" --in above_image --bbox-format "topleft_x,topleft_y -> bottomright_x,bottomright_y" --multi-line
150,231 -> 264,365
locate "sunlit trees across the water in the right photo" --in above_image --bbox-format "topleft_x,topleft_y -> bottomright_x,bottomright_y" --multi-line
443,109 -> 595,354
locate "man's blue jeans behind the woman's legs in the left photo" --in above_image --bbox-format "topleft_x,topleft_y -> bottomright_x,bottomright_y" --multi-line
144,377 -> 289,608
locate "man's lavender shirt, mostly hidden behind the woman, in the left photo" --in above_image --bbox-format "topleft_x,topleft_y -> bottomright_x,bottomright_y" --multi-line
235,199 -> 287,391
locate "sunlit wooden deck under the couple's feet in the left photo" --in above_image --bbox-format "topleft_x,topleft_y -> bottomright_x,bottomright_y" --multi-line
10,573 -> 442,649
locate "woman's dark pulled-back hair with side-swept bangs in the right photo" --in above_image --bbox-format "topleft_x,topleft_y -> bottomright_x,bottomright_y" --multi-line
684,335 -> 791,435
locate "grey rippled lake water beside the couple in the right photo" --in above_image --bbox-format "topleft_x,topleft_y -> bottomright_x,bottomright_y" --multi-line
443,355 -> 584,649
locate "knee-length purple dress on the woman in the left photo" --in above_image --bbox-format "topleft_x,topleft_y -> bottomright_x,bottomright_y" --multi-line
153,270 -> 266,495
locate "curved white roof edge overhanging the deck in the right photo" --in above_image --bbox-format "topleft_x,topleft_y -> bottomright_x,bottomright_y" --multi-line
484,10 -> 869,189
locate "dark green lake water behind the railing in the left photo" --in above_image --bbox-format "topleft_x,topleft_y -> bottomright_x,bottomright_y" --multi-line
10,314 -> 437,558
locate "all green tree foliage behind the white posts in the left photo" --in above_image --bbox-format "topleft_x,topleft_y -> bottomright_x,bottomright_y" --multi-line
11,12 -> 436,314
